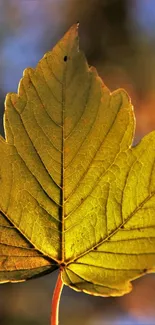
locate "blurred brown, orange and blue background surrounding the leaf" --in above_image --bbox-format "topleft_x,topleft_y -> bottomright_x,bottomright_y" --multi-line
0,0 -> 155,325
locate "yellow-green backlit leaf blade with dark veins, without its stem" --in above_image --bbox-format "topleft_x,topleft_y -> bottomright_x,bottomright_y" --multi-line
0,26 -> 155,296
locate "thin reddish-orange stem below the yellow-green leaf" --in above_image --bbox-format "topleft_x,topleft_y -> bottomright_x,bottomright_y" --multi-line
51,270 -> 63,325
